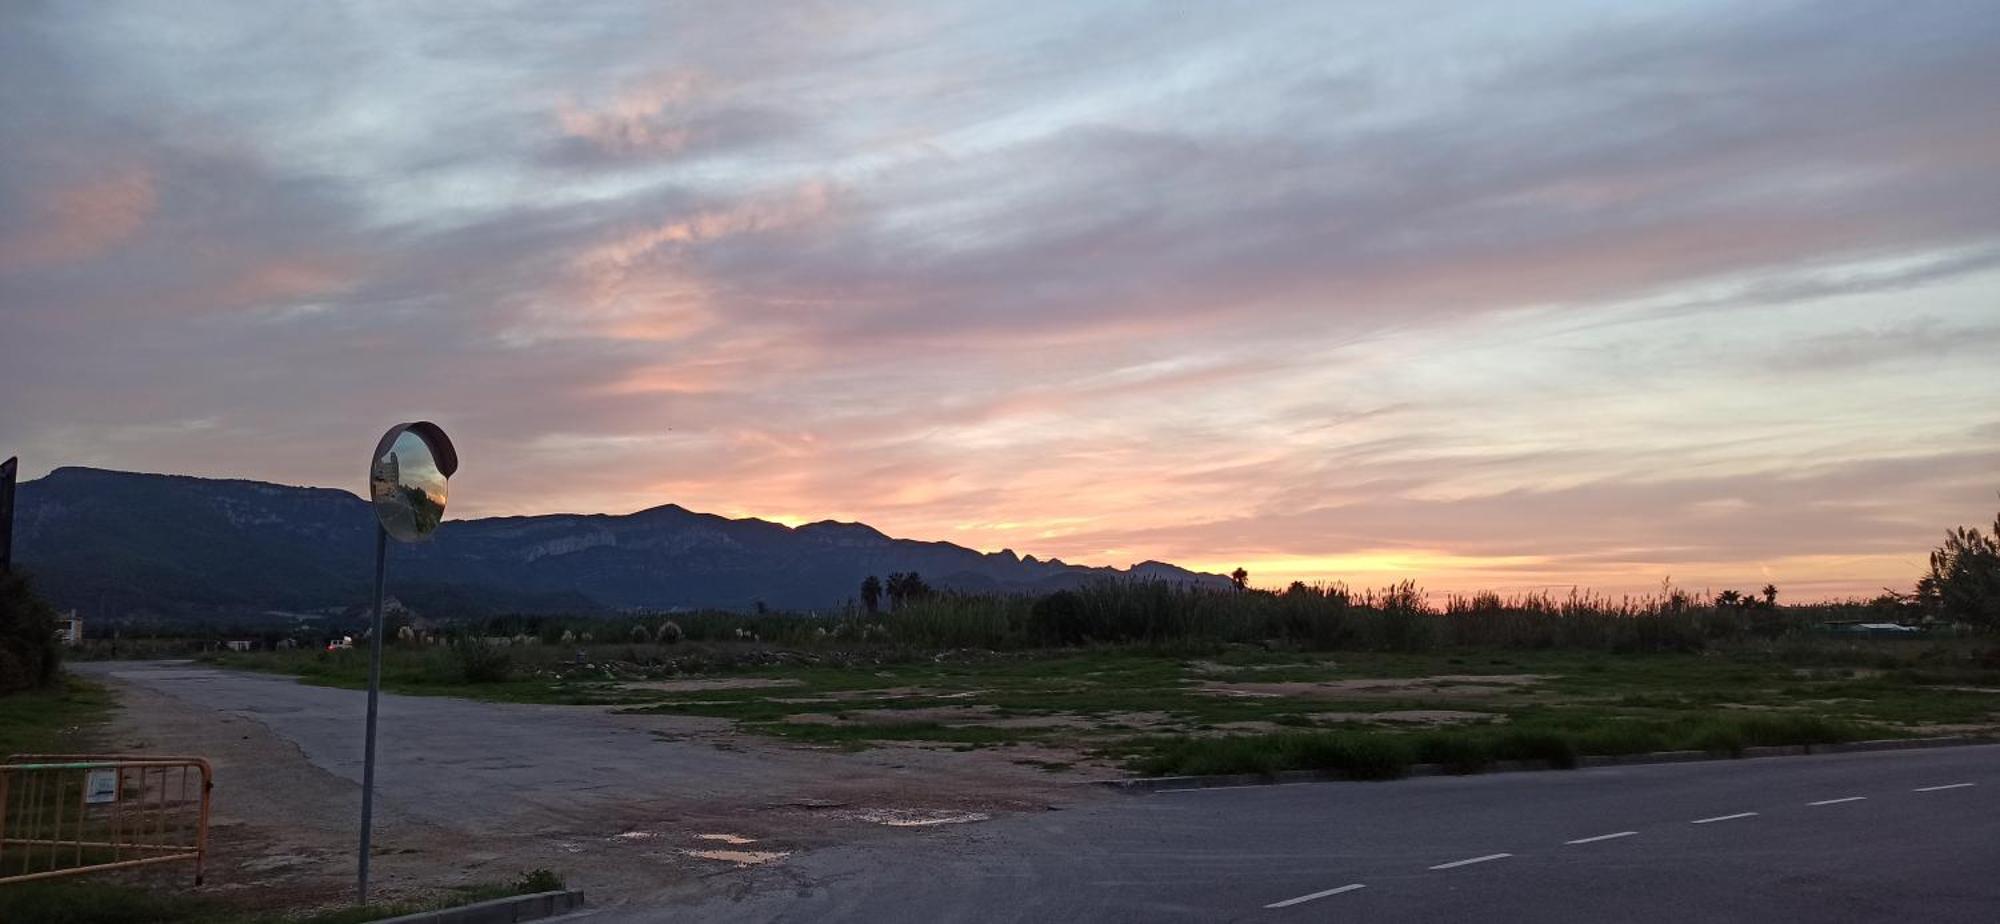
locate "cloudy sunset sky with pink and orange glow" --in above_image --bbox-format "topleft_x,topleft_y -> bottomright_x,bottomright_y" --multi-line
0,0 -> 2000,600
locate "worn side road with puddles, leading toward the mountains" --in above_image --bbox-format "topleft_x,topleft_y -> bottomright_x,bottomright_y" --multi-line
76,662 -> 1092,904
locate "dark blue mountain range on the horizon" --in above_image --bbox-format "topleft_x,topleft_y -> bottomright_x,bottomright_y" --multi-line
14,468 -> 1228,618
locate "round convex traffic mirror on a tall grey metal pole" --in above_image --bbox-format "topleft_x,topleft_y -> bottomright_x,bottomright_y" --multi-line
356,420 -> 458,904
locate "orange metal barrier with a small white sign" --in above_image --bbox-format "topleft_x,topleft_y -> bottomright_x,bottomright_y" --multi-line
0,754 -> 214,886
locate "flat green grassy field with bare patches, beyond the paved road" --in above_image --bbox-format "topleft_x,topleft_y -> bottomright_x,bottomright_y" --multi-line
203,640 -> 2000,760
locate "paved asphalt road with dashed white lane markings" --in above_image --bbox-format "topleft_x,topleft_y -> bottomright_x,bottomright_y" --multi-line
578,746 -> 2000,924
